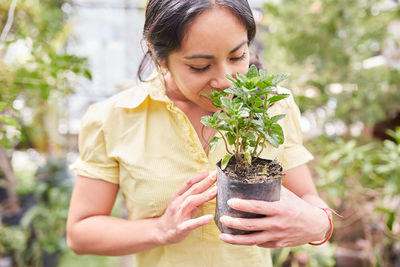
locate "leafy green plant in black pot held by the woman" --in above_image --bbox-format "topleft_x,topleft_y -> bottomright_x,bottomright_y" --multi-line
201,65 -> 289,234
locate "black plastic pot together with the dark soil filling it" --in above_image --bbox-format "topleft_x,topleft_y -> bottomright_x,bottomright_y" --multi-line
214,157 -> 282,235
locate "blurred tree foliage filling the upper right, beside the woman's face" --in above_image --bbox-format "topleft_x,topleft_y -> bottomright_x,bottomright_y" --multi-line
259,0 -> 400,125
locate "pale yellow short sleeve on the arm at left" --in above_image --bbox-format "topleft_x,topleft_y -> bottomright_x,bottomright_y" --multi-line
71,105 -> 119,184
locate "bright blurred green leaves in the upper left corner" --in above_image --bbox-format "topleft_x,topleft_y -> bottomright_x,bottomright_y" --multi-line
0,0 -> 91,149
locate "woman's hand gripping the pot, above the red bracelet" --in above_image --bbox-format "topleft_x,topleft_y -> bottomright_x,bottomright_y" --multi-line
220,186 -> 330,248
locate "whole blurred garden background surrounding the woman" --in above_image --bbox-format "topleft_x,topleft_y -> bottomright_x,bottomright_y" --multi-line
0,0 -> 400,267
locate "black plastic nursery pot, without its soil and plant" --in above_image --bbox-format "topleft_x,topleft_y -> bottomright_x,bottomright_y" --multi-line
214,158 -> 282,235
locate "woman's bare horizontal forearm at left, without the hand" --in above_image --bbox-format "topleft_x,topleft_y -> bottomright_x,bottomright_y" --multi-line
67,216 -> 164,256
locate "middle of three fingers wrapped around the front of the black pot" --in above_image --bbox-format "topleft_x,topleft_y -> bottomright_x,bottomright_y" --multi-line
220,215 -> 271,231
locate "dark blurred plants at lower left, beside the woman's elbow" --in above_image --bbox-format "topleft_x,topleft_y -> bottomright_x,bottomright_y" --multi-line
0,158 -> 73,267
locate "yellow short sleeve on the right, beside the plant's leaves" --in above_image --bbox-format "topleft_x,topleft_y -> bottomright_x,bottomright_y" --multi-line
282,91 -> 313,170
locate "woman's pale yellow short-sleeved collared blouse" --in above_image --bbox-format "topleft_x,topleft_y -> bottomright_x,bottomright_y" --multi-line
72,70 -> 312,267
